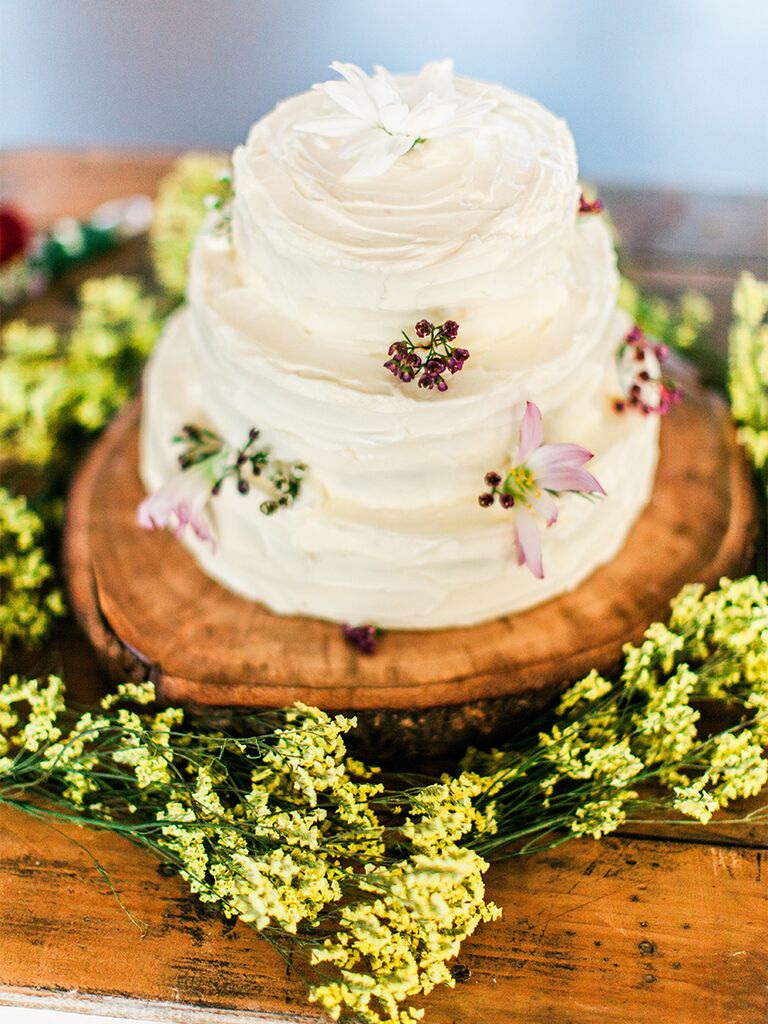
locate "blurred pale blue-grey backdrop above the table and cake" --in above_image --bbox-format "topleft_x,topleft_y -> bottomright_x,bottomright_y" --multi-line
0,0 -> 768,194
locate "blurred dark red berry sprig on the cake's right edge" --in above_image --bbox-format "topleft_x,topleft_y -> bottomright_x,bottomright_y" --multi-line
613,325 -> 682,416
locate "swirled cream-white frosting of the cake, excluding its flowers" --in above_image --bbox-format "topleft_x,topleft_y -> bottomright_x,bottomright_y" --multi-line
141,72 -> 657,629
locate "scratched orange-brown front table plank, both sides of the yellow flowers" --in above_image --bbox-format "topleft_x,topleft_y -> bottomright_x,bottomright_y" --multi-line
0,809 -> 768,1024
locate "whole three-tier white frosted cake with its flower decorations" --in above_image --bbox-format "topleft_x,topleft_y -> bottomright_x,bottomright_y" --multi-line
138,61 -> 674,630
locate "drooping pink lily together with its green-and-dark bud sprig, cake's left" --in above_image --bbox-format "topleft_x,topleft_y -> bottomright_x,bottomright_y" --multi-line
136,424 -> 306,548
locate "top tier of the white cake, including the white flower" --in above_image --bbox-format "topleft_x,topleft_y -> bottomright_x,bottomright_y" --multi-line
234,60 -> 579,269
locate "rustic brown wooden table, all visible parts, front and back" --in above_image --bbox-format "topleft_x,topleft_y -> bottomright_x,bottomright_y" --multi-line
0,152 -> 768,1024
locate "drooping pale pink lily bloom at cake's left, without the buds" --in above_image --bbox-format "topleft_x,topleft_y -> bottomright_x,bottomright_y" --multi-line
136,460 -> 216,548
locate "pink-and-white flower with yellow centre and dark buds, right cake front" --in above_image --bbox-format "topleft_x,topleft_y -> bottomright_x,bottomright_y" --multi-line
478,401 -> 605,580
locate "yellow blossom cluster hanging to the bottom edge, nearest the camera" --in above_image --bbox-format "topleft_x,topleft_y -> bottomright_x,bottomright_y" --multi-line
310,772 -> 501,1024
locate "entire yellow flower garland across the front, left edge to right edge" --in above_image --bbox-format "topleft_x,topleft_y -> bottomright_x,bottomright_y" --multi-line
0,578 -> 768,1024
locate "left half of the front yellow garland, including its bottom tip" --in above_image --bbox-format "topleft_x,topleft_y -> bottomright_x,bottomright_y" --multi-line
0,678 -> 500,1024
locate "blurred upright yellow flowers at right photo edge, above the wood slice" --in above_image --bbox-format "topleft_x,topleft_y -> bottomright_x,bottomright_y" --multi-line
728,273 -> 768,471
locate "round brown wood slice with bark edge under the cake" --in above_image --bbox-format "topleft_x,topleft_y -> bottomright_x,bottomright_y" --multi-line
65,376 -> 757,751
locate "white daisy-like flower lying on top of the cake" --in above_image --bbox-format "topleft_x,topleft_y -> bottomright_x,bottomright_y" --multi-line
296,60 -> 497,178
